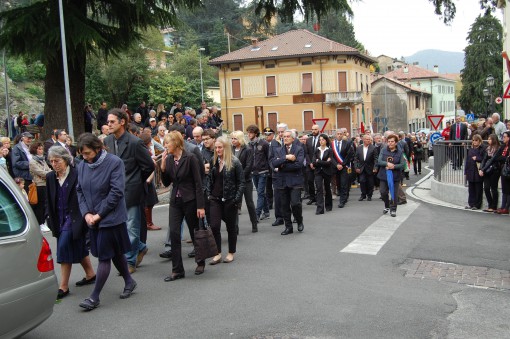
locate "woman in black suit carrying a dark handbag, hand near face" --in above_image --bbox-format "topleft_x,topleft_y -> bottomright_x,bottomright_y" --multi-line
161,131 -> 205,281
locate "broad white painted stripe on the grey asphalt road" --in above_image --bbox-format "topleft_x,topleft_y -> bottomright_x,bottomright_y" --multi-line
340,200 -> 420,255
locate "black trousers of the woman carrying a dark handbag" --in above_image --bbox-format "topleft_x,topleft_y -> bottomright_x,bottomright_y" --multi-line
169,198 -> 202,273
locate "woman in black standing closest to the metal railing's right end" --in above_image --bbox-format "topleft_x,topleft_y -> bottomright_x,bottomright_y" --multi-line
464,134 -> 485,210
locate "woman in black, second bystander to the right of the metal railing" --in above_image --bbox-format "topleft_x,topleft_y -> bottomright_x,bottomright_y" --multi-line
479,134 -> 501,212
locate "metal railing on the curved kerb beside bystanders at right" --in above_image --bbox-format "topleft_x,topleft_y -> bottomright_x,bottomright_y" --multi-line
434,140 -> 471,186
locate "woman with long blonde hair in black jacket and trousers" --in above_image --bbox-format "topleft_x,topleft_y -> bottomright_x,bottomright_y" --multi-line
206,136 -> 244,265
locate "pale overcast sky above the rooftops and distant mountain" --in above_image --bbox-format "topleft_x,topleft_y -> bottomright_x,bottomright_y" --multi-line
351,0 -> 503,58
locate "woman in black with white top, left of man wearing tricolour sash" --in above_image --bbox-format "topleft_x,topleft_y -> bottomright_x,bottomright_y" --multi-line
312,134 -> 335,214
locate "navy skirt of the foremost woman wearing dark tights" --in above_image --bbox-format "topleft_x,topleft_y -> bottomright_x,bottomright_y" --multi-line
89,223 -> 131,260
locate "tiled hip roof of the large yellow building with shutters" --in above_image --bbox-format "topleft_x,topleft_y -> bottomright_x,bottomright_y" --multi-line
209,29 -> 377,65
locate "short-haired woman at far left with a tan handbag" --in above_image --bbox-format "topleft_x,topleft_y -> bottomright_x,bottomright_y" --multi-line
28,141 -> 51,232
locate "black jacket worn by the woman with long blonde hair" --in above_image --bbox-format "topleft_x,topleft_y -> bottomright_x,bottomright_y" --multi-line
206,157 -> 244,203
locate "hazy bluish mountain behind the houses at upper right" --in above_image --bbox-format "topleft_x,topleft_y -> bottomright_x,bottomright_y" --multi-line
404,49 -> 464,73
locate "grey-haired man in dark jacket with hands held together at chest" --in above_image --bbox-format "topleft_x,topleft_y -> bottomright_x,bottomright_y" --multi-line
270,130 -> 305,235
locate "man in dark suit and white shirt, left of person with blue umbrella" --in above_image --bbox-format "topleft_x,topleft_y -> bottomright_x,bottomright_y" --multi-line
354,134 -> 377,201
